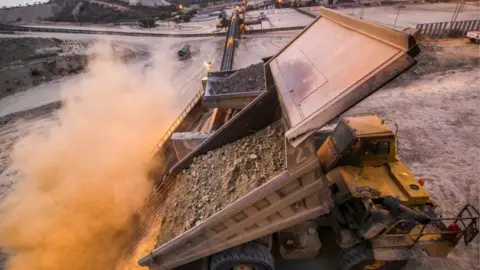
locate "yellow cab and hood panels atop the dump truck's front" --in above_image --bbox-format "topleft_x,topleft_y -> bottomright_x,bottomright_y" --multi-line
317,115 -> 429,205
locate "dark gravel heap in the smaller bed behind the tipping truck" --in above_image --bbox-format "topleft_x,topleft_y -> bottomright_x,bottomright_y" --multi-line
210,63 -> 265,95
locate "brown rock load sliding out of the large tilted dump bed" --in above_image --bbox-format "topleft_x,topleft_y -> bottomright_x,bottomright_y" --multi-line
157,121 -> 286,245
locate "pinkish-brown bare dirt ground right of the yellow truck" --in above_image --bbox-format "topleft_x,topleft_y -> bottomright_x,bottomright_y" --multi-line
346,39 -> 480,269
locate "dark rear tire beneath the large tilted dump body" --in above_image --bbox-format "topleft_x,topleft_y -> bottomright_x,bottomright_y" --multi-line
210,242 -> 275,270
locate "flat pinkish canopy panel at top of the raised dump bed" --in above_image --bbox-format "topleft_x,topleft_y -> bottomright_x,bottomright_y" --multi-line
268,9 -> 420,143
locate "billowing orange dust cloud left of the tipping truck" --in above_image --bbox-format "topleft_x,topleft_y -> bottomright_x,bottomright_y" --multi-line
0,43 -> 178,270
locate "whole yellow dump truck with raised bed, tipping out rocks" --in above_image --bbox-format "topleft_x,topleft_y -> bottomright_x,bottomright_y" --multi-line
139,9 -> 478,270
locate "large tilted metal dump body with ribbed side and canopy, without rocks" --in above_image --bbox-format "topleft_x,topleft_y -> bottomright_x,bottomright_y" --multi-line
139,9 -> 418,269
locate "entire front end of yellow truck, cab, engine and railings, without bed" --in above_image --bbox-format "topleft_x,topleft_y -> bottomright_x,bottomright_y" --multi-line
317,115 -> 478,269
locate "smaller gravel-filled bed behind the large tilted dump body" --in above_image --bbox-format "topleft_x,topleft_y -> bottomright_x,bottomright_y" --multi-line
202,63 -> 266,109
